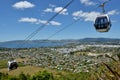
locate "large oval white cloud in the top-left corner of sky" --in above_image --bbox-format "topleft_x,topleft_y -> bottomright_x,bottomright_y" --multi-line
13,1 -> 35,9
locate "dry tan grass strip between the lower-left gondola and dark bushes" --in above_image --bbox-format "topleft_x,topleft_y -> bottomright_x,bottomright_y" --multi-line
0,66 -> 67,76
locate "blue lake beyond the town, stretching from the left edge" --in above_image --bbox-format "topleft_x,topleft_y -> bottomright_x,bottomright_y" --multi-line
0,40 -> 65,48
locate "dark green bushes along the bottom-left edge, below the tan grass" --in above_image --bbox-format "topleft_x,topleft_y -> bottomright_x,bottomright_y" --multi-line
0,71 -> 54,80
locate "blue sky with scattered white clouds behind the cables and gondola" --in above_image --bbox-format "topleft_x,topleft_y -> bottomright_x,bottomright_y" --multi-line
0,0 -> 120,42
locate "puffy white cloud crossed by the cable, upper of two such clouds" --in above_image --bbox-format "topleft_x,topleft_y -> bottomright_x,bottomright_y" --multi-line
44,7 -> 68,15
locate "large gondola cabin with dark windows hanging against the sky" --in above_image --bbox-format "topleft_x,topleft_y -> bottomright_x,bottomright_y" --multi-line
94,14 -> 111,32
